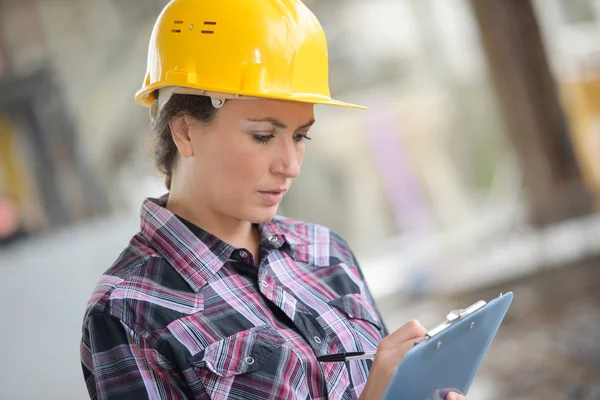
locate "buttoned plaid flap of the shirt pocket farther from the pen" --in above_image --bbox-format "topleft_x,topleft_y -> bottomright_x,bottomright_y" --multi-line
190,325 -> 285,377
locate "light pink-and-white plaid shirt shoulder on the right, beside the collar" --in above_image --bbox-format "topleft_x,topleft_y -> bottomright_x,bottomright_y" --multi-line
274,216 -> 358,268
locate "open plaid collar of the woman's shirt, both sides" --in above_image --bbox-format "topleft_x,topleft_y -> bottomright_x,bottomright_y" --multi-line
141,194 -> 306,292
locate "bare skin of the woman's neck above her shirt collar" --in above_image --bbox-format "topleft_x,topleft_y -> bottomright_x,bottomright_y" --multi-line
166,192 -> 260,252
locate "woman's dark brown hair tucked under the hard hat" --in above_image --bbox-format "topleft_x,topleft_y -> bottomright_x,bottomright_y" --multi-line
152,94 -> 217,190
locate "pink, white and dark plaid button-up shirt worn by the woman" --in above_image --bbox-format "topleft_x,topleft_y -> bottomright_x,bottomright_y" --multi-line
81,196 -> 387,400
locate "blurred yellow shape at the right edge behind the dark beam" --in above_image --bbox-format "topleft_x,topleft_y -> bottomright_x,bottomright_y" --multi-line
561,75 -> 600,207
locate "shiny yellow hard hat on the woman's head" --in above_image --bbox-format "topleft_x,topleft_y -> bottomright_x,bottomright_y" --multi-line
135,0 -> 366,109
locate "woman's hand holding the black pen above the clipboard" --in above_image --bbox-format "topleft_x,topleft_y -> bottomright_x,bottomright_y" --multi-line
360,320 -> 426,400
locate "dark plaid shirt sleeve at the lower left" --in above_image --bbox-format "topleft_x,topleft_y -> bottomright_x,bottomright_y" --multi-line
81,314 -> 187,400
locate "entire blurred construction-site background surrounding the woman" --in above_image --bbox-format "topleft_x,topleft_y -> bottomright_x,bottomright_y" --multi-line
0,0 -> 600,400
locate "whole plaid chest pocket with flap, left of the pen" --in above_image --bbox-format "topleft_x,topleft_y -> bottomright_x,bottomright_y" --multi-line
190,325 -> 300,400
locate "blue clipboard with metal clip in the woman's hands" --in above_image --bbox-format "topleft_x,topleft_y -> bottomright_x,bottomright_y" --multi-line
382,292 -> 513,400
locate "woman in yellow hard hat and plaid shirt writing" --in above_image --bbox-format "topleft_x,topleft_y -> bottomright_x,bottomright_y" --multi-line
81,0 -> 466,400
